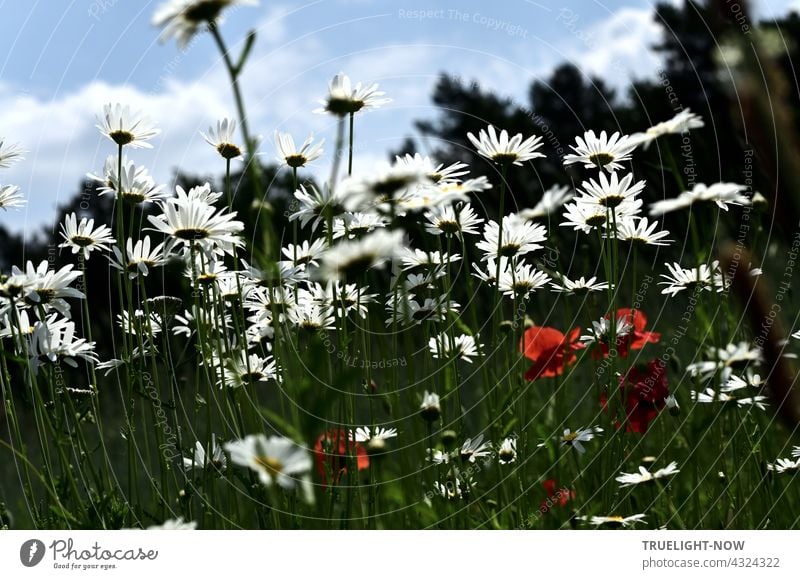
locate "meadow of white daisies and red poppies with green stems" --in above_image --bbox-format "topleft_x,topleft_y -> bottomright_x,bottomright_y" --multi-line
0,0 -> 800,529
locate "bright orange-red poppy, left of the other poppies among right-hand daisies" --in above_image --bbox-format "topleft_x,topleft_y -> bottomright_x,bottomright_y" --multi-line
519,326 -> 583,380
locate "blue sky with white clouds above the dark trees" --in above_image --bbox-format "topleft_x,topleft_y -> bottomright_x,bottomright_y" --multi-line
0,0 -> 792,238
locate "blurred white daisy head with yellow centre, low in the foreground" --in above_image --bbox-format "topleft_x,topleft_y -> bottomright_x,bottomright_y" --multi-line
223,434 -> 312,490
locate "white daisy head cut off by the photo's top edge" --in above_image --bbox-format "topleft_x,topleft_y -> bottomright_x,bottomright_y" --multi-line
152,0 -> 258,48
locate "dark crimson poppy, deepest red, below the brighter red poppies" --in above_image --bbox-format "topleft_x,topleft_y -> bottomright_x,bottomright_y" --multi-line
600,359 -> 669,434
